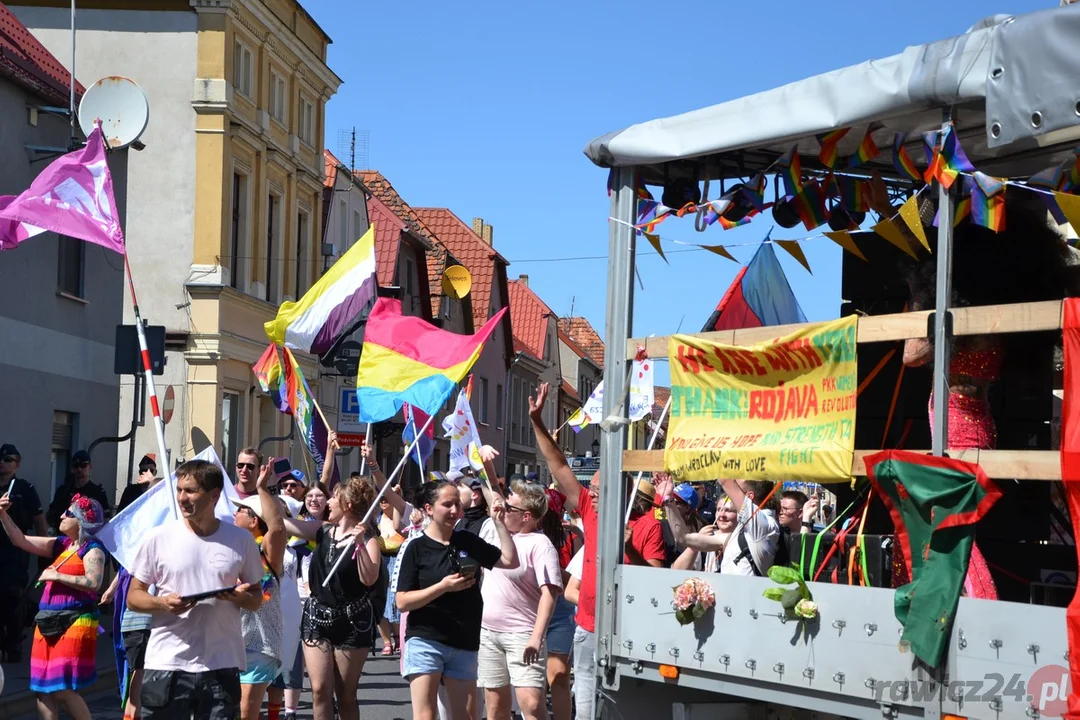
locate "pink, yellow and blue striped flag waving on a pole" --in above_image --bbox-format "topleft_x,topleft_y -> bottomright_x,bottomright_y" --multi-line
356,298 -> 507,422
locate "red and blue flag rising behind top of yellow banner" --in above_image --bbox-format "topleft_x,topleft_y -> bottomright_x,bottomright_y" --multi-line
702,237 -> 807,332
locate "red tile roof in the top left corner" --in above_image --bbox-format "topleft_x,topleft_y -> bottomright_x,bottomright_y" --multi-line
0,2 -> 85,107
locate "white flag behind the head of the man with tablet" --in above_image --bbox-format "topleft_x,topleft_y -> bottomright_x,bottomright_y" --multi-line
96,447 -> 240,569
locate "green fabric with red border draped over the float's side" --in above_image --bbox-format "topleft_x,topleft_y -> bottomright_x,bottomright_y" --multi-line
866,450 -> 1001,667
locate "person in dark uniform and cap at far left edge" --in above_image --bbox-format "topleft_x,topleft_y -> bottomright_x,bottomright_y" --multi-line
0,443 -> 49,663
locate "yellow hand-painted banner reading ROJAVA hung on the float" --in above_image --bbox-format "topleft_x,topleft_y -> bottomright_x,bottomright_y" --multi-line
664,316 -> 859,483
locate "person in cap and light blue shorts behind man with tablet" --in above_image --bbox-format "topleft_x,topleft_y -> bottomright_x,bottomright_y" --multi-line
233,458 -> 289,720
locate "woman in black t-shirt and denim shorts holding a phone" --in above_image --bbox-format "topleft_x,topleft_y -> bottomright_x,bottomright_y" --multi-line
395,483 -> 518,720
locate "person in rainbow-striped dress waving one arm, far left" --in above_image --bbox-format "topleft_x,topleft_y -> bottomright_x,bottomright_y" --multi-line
0,493 -> 105,720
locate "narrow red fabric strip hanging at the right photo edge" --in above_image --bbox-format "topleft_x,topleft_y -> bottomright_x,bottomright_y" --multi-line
1062,298 -> 1080,720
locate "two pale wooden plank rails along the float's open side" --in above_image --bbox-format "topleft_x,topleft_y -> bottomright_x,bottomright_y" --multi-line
622,300 -> 1064,480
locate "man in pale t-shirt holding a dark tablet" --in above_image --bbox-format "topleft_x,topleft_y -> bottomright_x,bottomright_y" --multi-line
127,460 -> 264,720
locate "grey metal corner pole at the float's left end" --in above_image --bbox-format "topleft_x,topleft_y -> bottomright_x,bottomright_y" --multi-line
595,167 -> 637,699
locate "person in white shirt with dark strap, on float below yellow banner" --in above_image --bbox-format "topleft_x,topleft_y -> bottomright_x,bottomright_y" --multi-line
720,480 -> 780,578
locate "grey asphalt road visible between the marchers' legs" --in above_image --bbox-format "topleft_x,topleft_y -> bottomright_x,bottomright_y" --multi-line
17,655 -> 413,720
